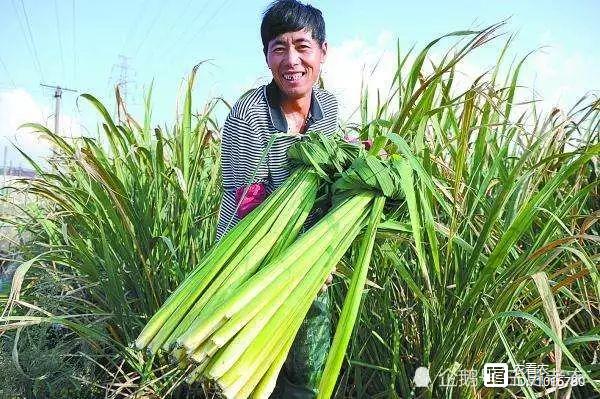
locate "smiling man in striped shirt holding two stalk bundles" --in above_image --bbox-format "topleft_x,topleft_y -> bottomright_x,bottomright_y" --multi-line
217,0 -> 338,399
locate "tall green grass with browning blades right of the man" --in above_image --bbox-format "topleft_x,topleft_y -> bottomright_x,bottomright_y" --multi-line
335,22 -> 600,398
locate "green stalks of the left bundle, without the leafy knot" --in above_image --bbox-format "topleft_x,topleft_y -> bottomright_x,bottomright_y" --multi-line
135,167 -> 318,354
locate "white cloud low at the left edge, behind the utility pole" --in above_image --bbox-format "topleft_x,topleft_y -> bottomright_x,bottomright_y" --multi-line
0,88 -> 80,168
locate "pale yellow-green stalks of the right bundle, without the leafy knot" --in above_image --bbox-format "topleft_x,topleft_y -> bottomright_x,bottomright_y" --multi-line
181,194 -> 372,397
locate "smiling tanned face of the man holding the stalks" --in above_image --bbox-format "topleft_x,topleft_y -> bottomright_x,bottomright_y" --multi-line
267,29 -> 327,99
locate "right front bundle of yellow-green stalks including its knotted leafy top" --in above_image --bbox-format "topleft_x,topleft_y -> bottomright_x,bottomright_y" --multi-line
169,155 -> 403,398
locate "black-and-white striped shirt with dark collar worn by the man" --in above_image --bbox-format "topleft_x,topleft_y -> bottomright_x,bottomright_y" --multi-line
217,81 -> 338,240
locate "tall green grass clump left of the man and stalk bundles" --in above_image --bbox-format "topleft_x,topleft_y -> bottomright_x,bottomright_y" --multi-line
3,68 -> 220,391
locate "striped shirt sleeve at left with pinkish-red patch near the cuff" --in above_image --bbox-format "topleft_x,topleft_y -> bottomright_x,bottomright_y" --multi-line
217,111 -> 269,240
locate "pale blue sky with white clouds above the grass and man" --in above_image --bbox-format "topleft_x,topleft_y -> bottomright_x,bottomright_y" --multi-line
0,0 -> 600,168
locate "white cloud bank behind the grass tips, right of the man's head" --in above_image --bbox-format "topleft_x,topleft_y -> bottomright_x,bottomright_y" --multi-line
323,31 -> 600,122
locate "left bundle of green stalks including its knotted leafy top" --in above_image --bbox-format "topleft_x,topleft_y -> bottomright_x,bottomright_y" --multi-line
135,134 -> 358,360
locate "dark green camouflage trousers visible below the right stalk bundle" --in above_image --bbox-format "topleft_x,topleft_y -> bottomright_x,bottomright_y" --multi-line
271,292 -> 331,399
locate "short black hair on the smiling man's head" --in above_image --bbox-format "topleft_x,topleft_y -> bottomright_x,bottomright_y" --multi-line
260,0 -> 325,55
